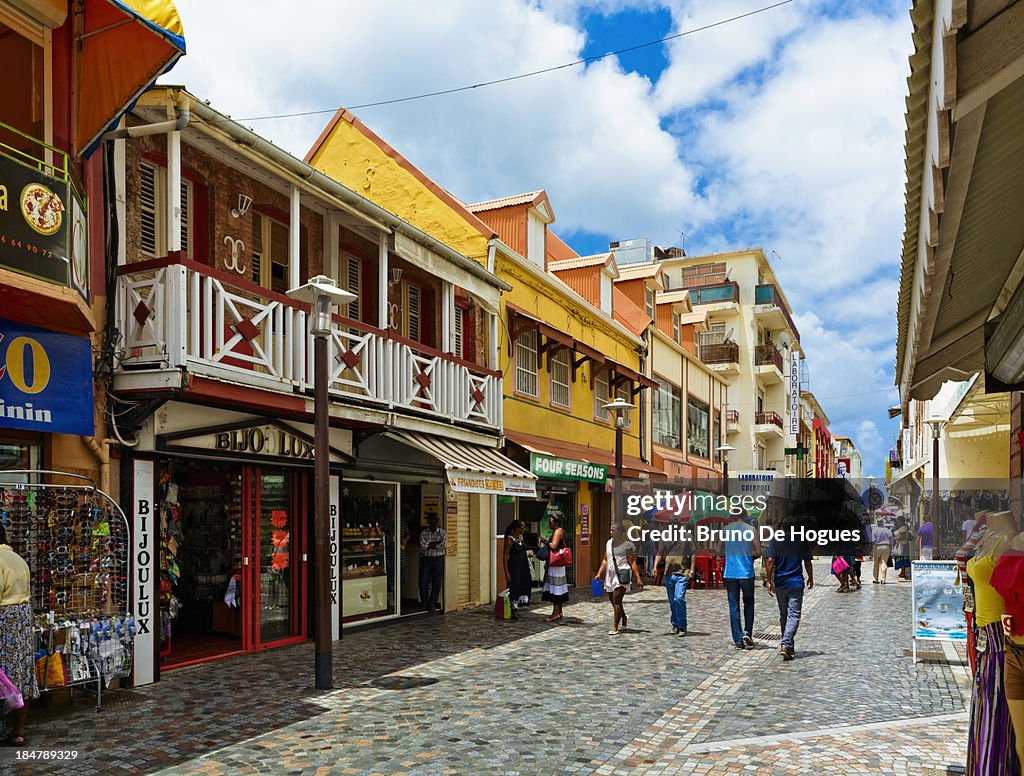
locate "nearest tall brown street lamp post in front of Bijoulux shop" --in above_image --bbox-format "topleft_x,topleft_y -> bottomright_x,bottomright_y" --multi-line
288,274 -> 356,690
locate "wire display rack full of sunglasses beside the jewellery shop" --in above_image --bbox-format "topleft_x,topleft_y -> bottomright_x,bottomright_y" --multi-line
0,471 -> 135,710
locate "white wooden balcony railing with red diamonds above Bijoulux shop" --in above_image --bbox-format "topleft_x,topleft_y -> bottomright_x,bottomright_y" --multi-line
117,259 -> 502,430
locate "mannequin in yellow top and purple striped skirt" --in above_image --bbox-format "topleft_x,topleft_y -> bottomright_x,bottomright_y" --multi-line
967,512 -> 1024,776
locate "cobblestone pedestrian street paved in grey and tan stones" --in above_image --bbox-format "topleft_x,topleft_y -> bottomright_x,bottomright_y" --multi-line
7,562 -> 969,774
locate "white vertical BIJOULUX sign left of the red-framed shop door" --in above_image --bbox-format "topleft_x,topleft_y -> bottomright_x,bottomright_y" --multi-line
131,461 -> 160,687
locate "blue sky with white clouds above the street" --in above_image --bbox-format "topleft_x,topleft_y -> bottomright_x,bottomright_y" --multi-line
164,0 -> 911,474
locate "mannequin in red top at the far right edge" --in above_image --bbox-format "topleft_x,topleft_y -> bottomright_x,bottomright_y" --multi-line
992,513 -> 1024,763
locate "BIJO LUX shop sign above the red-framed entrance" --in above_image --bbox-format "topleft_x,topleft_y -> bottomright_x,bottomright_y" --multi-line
157,421 -> 352,464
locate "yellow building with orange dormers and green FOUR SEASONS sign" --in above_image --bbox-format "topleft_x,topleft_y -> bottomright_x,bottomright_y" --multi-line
306,111 -> 655,589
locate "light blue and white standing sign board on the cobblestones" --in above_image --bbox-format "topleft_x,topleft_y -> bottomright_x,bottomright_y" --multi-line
910,560 -> 967,641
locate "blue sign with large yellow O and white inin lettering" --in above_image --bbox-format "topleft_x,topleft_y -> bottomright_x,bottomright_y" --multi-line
0,318 -> 95,436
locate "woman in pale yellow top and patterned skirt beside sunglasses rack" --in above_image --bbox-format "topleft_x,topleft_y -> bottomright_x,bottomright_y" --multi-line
0,525 -> 39,746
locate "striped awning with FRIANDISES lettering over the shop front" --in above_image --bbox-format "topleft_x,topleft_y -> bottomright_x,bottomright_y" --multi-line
388,431 -> 537,495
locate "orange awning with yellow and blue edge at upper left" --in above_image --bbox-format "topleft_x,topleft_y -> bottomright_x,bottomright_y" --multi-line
75,0 -> 185,154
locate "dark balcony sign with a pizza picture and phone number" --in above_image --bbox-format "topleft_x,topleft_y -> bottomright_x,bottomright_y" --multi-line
0,156 -> 89,301
